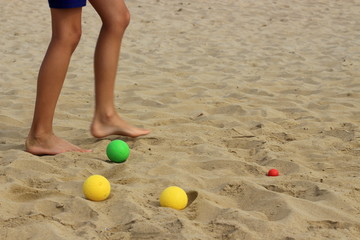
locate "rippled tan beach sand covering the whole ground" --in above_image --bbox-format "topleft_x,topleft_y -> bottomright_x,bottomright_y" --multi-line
0,0 -> 360,240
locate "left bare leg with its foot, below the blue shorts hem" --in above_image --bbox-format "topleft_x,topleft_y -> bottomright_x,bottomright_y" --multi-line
25,8 -> 88,155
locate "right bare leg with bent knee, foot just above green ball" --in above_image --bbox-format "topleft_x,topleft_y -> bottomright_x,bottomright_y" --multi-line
90,0 -> 149,138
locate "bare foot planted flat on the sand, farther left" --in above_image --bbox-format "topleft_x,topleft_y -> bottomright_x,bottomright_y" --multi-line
25,134 -> 91,155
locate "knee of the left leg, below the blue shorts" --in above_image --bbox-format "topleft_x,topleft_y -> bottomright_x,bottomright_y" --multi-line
52,28 -> 82,52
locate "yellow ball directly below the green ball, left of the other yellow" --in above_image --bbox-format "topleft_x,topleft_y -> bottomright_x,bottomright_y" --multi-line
83,175 -> 111,201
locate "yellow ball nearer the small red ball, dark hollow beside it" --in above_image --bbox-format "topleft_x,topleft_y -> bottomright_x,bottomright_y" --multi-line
160,186 -> 188,210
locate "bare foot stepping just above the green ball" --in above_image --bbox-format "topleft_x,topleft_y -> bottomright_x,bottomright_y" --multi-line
91,114 -> 150,138
